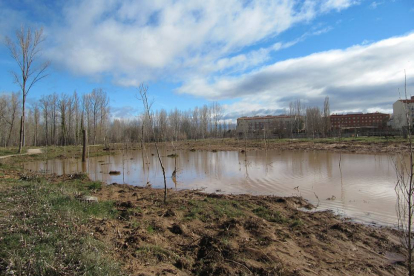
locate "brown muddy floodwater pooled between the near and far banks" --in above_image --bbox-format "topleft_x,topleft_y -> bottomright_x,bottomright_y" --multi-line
24,149 -> 396,225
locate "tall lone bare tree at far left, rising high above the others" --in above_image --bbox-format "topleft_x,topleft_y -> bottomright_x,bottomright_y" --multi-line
6,26 -> 49,153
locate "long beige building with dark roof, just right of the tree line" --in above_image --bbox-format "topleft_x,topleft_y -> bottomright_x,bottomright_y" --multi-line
236,115 -> 303,138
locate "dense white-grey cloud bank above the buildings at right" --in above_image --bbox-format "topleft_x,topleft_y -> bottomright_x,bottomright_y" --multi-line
177,33 -> 414,117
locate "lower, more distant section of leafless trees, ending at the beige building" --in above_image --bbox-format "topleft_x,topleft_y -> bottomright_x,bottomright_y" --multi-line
109,102 -> 235,143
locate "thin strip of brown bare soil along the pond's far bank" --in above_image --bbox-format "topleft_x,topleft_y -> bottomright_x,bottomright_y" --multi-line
171,139 -> 409,153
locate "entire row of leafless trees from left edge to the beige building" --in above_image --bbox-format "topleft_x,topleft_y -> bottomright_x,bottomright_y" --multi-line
0,88 -> 234,147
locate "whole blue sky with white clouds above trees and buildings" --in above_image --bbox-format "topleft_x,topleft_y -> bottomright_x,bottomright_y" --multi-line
0,0 -> 414,118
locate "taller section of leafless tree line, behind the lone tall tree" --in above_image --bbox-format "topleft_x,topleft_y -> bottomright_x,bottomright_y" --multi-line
0,89 -> 110,147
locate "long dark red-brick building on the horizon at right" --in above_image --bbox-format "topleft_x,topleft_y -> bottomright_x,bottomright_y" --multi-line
330,112 -> 390,130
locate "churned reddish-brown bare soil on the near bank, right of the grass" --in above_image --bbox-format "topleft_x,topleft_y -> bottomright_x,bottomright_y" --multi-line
83,184 -> 407,275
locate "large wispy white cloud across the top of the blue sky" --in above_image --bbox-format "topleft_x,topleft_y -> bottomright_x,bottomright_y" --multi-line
47,0 -> 356,85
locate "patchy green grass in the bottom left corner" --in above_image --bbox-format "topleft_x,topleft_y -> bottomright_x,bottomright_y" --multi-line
0,180 -> 122,275
